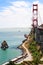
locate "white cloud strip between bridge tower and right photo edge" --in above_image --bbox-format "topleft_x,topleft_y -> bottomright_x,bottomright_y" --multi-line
38,2 -> 43,25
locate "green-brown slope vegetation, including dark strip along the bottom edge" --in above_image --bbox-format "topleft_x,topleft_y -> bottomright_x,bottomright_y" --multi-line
7,29 -> 43,65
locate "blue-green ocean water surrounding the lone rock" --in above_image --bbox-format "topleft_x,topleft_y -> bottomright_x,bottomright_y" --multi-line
0,28 -> 30,65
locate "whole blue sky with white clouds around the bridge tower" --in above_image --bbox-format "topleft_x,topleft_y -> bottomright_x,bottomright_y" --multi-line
0,0 -> 43,28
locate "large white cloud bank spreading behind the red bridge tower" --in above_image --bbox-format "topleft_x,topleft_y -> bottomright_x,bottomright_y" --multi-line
0,1 -> 43,28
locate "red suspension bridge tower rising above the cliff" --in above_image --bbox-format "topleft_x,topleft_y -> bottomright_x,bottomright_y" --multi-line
32,4 -> 38,28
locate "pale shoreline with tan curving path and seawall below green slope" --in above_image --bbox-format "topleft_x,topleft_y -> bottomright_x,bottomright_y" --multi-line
2,34 -> 32,65
